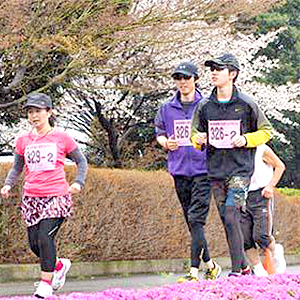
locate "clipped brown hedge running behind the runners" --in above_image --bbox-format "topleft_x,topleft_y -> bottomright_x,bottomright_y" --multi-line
0,164 -> 300,263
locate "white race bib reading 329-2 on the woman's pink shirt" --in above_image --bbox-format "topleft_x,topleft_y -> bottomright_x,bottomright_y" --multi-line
25,143 -> 57,171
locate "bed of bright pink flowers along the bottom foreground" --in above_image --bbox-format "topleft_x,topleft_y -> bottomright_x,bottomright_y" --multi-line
0,274 -> 300,300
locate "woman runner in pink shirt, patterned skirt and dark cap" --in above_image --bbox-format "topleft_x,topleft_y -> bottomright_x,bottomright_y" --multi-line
1,93 -> 87,298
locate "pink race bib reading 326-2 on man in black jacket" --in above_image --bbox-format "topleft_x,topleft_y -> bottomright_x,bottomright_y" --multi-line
208,120 -> 241,149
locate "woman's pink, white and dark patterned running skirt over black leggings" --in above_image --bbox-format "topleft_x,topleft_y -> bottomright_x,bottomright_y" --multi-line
20,194 -> 73,227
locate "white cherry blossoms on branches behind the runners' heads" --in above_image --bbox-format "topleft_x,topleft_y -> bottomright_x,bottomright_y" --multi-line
0,21 -> 300,149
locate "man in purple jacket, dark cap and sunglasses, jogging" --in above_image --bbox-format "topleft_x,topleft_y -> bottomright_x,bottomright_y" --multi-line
155,62 -> 221,282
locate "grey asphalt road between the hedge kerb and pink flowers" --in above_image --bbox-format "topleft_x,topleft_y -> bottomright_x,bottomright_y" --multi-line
0,265 -> 300,300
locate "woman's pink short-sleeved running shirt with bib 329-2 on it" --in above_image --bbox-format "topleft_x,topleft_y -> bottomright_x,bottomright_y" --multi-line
15,129 -> 77,197
